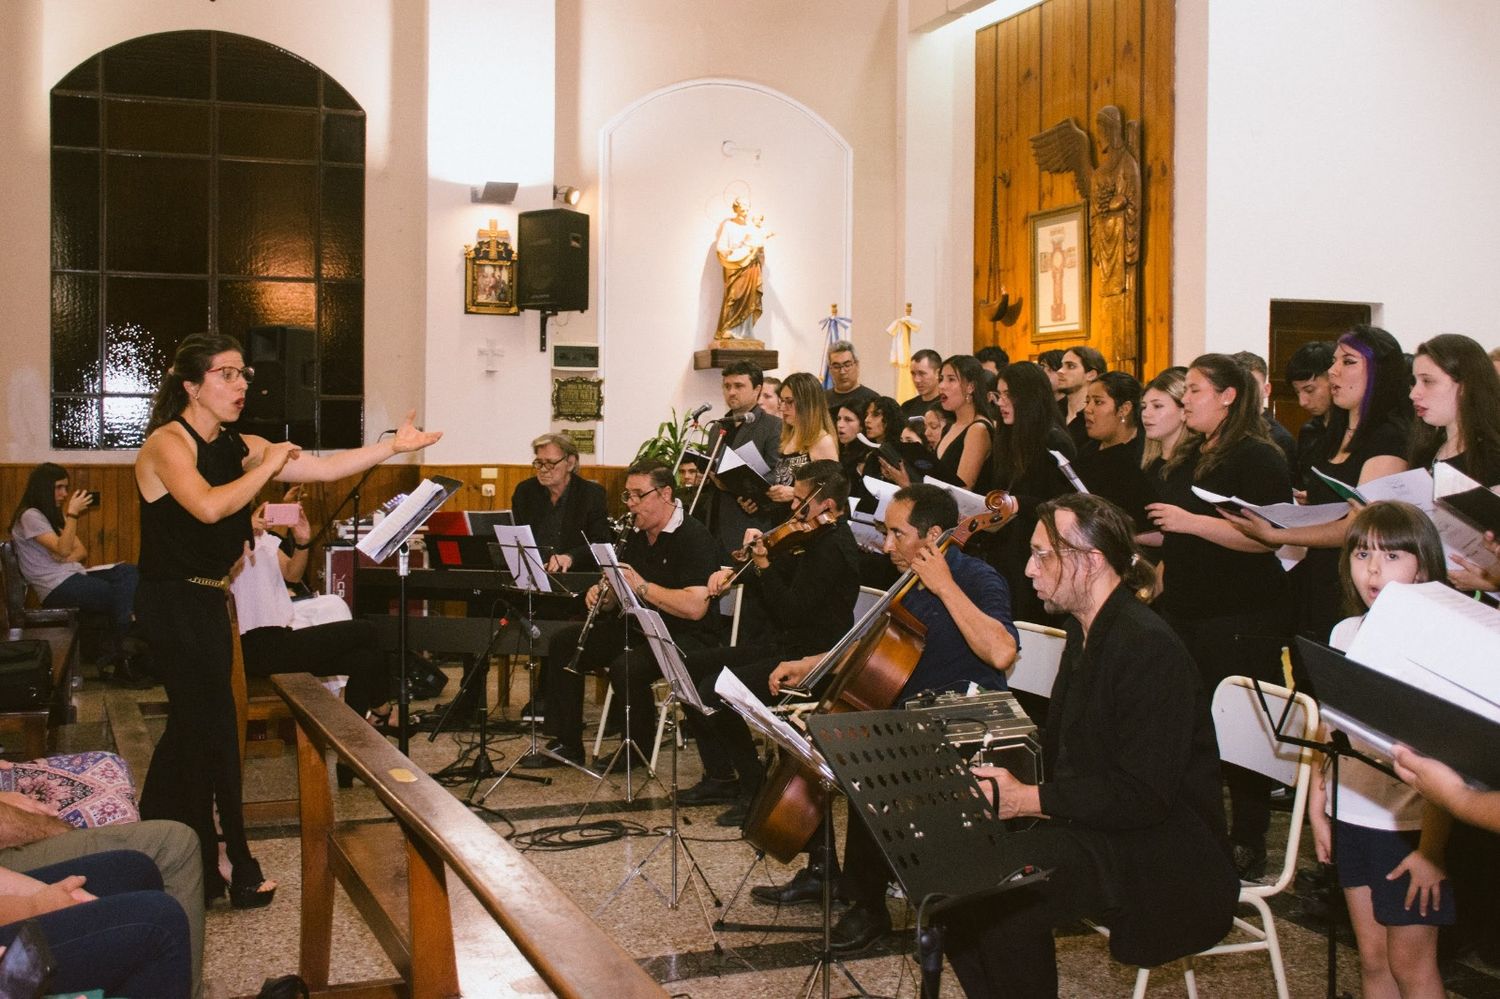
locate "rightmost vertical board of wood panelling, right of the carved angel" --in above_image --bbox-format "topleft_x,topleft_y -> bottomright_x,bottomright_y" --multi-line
1142,0 -> 1178,378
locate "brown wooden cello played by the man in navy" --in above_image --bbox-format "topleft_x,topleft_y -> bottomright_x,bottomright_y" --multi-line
744,491 -> 1019,864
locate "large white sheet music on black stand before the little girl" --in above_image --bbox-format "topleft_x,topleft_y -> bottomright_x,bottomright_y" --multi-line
1347,582 -> 1500,723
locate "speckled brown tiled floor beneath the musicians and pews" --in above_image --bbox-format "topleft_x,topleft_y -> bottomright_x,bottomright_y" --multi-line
85,660 -> 1500,999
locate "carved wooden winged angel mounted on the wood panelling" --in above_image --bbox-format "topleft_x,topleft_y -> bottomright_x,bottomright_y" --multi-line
1031,104 -> 1145,368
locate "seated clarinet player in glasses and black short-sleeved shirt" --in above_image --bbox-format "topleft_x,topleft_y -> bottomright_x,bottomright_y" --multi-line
522,461 -> 723,768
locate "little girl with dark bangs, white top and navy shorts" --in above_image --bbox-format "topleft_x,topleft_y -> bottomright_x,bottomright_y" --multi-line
1308,503 -> 1457,996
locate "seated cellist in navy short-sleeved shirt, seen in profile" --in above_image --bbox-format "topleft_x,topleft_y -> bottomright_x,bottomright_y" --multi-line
752,485 -> 1019,918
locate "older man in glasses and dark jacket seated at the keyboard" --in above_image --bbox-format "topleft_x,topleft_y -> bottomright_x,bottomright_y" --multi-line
510,434 -> 612,573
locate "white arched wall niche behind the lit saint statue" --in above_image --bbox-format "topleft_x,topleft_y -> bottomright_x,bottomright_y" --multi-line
597,80 -> 858,464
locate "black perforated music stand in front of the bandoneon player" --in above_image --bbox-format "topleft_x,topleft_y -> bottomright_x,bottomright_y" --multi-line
807,711 -> 1047,999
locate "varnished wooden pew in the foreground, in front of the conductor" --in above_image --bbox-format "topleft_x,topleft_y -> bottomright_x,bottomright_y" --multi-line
272,674 -> 666,999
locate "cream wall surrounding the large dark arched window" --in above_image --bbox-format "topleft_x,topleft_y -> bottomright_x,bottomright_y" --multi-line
0,0 -> 428,462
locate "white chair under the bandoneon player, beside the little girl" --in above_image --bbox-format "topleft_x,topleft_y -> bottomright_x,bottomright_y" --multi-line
1095,677 -> 1319,999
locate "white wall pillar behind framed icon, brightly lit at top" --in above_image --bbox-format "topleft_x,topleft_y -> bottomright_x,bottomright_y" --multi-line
423,0 -> 555,464
